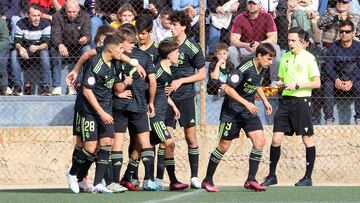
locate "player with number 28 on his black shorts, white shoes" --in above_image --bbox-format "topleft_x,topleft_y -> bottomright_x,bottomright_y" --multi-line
68,35 -> 124,193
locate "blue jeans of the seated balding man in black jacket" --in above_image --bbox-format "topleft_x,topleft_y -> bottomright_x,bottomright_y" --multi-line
50,45 -> 90,87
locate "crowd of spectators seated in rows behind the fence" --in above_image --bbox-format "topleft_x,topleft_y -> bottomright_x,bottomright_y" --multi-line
0,0 -> 360,124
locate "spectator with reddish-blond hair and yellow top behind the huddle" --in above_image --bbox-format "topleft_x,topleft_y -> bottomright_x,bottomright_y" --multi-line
110,3 -> 137,29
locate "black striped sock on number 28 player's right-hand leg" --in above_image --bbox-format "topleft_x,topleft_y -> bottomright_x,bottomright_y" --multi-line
94,145 -> 111,186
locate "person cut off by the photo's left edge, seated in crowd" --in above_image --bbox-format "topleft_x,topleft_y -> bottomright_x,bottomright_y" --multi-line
0,12 -> 12,95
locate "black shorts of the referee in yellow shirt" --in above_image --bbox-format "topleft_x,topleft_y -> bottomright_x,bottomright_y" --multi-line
273,96 -> 314,136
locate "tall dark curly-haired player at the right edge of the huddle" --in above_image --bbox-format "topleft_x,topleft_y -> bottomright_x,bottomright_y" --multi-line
166,11 -> 206,189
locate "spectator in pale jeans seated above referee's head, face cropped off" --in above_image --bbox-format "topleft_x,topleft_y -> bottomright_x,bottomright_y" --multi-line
288,0 -> 321,44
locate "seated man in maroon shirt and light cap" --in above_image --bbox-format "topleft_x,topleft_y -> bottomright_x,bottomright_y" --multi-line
229,0 -> 280,85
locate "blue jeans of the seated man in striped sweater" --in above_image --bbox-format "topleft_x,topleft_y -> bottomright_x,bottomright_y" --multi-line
11,49 -> 51,86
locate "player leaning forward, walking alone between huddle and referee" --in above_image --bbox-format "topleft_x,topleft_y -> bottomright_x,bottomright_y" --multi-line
202,43 -> 276,192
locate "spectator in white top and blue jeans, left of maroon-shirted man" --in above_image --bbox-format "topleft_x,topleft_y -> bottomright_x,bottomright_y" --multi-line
208,0 -> 240,54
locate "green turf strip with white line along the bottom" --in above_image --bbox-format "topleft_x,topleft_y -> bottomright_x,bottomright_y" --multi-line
0,186 -> 360,203
